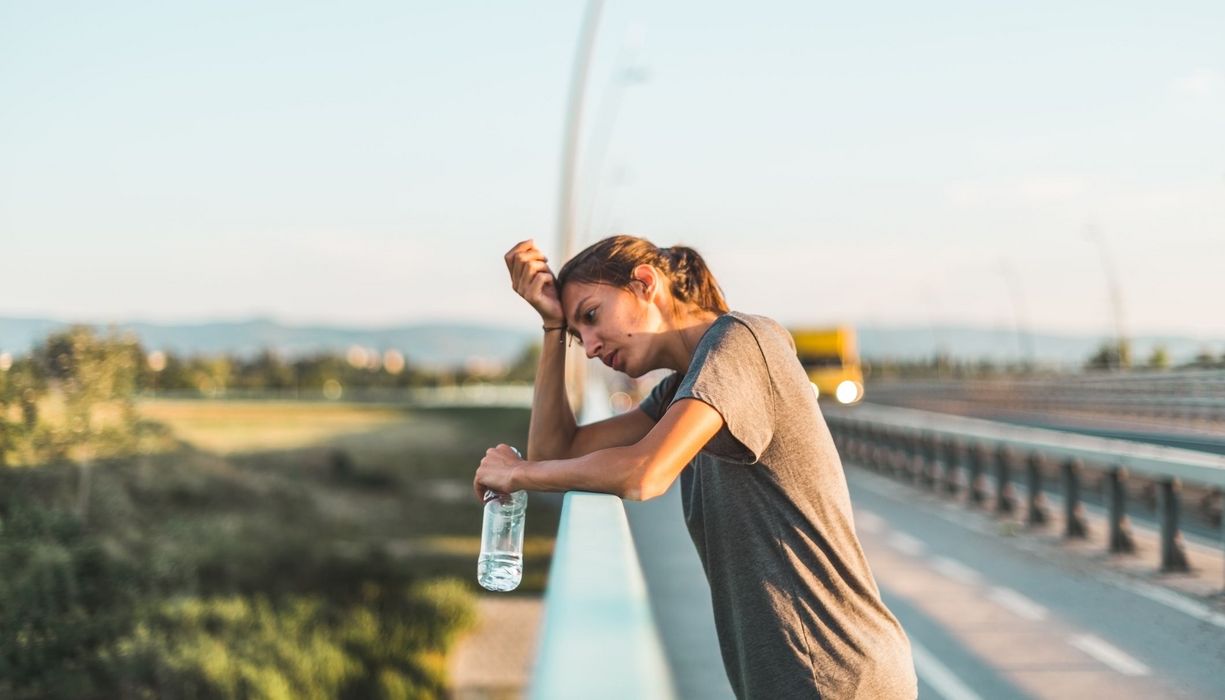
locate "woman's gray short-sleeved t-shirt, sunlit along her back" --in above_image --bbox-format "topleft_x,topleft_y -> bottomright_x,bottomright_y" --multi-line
639,311 -> 918,700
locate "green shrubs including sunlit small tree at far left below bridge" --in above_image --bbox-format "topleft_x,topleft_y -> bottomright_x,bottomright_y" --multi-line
0,329 -> 487,700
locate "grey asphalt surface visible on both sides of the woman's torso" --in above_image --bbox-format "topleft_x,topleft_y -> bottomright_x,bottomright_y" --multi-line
626,467 -> 1225,700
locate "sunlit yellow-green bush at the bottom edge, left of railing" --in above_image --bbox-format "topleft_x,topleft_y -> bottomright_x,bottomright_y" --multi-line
104,581 -> 474,700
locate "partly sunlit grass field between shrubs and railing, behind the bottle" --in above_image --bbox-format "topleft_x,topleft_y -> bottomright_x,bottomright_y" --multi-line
140,401 -> 560,593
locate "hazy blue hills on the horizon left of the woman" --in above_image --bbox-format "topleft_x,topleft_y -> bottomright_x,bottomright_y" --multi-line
0,318 -> 535,368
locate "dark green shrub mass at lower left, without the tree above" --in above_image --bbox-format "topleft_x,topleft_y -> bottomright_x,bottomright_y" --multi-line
0,451 -> 473,698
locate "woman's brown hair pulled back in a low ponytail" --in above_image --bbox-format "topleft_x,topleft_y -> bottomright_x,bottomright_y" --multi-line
557,235 -> 728,314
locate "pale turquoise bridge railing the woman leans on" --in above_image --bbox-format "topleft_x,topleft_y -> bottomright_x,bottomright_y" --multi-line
530,379 -> 676,700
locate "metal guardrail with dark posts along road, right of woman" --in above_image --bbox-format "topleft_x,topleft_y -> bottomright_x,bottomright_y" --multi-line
826,405 -> 1225,573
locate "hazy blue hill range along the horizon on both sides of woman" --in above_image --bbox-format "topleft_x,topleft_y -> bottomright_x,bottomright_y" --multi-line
0,318 -> 1225,368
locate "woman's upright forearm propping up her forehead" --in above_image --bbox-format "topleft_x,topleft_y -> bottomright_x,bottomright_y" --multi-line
526,330 -> 578,460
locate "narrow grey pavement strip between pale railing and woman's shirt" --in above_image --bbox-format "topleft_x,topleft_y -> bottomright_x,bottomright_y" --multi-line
625,479 -> 734,700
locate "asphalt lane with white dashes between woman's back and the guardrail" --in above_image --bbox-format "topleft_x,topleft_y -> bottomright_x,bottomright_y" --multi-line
848,467 -> 1225,699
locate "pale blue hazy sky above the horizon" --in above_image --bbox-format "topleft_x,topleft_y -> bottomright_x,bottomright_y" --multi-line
0,0 -> 1225,338
